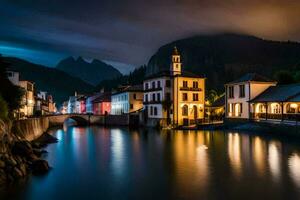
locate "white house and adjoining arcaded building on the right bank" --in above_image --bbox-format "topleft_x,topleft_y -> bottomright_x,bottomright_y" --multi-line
225,73 -> 300,121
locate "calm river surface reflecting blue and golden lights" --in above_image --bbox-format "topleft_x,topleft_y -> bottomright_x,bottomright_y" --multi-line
2,126 -> 300,200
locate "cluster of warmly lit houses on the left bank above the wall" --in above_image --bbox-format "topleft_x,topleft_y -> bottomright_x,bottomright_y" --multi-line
7,69 -> 57,119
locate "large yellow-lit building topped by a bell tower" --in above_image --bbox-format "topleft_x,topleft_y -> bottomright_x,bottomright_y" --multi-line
143,47 -> 205,126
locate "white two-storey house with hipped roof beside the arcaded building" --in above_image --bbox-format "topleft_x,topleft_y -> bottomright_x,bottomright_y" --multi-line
225,73 -> 277,119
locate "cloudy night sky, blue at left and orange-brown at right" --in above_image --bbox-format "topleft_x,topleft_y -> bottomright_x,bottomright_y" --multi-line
0,0 -> 300,72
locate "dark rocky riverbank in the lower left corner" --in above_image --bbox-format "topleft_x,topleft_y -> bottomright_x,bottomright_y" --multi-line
0,120 -> 57,187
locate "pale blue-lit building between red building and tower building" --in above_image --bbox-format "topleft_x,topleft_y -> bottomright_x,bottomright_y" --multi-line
111,85 -> 143,115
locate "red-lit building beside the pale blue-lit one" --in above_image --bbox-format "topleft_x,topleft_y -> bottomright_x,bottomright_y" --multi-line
93,93 -> 111,115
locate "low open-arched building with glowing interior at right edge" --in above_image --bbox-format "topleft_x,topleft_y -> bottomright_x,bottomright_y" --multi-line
250,84 -> 300,120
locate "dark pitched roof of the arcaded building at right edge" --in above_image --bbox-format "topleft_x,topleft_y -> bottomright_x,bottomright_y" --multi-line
250,84 -> 300,102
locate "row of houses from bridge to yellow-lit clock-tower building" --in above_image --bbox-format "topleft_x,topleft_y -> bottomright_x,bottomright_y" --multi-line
62,47 -> 205,126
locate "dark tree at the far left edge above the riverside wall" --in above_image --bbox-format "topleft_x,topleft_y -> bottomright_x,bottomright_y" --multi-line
0,55 -> 24,112
